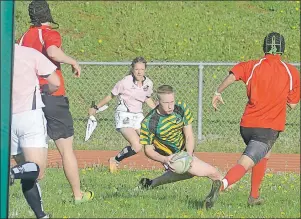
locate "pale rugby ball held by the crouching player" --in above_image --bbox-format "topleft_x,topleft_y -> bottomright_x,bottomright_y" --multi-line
169,151 -> 193,174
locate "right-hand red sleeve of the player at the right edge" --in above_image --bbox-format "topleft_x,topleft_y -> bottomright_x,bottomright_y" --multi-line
287,65 -> 300,104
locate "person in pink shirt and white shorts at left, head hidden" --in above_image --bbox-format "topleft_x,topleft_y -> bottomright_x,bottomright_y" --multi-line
11,44 -> 60,218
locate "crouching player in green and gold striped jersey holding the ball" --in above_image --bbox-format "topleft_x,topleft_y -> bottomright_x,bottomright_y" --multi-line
139,85 -> 222,192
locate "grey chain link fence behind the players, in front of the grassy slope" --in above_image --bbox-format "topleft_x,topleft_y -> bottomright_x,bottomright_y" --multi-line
58,62 -> 300,153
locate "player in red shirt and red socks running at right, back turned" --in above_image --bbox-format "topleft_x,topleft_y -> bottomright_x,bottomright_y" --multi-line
204,32 -> 300,208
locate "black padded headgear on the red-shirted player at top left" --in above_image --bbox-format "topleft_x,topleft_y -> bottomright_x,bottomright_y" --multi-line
28,0 -> 59,28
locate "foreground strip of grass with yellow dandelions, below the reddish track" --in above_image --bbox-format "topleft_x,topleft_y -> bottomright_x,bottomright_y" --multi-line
9,168 -> 300,218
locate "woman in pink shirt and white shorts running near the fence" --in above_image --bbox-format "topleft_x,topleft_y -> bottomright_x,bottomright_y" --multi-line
89,57 -> 155,173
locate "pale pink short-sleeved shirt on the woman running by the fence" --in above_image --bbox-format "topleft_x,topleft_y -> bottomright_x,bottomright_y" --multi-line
111,75 -> 153,113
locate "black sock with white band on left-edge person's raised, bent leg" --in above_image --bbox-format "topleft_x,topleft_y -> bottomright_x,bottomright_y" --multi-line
11,162 -> 40,181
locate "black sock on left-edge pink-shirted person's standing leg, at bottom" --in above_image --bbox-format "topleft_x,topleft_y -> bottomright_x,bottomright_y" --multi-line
21,179 -> 46,218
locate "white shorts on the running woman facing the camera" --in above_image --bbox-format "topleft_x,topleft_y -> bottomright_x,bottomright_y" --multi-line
115,111 -> 144,130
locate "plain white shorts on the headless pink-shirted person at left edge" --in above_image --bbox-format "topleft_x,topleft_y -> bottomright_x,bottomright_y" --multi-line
11,109 -> 48,155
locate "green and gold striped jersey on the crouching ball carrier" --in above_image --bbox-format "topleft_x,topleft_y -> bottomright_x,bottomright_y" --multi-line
140,102 -> 193,155
